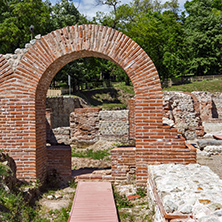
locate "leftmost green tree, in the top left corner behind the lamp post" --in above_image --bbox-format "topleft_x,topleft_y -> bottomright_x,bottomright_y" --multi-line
0,0 -> 50,54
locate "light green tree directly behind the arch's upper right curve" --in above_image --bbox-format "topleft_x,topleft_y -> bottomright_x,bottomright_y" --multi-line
109,0 -> 186,80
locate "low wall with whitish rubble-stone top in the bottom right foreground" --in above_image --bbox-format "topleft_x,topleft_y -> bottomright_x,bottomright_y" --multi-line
147,164 -> 222,222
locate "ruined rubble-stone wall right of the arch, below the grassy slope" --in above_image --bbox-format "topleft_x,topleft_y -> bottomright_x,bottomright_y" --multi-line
163,91 -> 222,139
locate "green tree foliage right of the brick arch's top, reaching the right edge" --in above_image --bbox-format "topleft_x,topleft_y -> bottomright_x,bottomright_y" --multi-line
94,0 -> 222,80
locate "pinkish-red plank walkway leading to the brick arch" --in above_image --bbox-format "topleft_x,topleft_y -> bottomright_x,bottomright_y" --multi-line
68,182 -> 119,222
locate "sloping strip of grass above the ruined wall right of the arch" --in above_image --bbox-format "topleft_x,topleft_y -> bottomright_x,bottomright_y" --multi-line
163,79 -> 222,93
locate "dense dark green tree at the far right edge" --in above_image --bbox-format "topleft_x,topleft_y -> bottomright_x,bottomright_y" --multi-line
185,0 -> 222,75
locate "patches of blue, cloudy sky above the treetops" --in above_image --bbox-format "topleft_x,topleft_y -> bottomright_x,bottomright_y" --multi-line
50,0 -> 186,19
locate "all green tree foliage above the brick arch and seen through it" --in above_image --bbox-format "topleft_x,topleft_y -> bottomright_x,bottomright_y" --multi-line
0,0 -> 222,89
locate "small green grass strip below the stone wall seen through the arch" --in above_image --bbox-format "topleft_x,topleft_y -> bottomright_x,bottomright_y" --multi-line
72,148 -> 110,160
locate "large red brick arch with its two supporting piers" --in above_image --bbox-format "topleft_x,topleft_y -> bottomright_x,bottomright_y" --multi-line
0,25 -> 195,183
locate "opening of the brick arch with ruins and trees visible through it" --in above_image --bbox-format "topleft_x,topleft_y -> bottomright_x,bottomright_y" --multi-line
46,57 -> 135,182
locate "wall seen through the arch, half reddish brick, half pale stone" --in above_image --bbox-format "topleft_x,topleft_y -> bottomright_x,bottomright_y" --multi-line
69,108 -> 129,146
